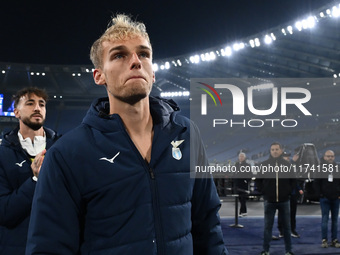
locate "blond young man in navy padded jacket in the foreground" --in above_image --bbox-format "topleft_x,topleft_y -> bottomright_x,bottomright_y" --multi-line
26,15 -> 228,255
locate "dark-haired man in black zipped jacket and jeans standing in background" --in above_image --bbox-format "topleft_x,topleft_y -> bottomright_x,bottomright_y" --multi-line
256,142 -> 296,255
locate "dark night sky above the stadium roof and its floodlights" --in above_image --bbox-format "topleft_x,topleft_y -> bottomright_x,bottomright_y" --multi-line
0,0 -> 338,65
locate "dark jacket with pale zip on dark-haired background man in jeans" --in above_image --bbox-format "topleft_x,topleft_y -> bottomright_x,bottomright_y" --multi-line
256,156 -> 296,202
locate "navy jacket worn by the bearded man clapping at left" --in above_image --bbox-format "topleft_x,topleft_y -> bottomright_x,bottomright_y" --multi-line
0,128 -> 58,255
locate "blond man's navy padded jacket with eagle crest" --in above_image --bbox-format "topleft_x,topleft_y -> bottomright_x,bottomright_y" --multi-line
26,97 -> 227,255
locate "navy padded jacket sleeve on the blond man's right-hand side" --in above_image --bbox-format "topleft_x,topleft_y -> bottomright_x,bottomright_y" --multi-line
192,122 -> 228,255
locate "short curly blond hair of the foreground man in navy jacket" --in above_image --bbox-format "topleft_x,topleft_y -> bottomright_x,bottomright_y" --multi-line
90,14 -> 151,68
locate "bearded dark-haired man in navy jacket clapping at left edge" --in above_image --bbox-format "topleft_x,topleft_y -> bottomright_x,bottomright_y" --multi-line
0,88 -> 58,255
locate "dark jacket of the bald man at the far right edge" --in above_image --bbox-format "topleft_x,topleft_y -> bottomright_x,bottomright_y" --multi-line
314,158 -> 340,200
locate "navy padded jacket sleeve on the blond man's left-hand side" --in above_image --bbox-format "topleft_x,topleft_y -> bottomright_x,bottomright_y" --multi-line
26,148 -> 81,255
